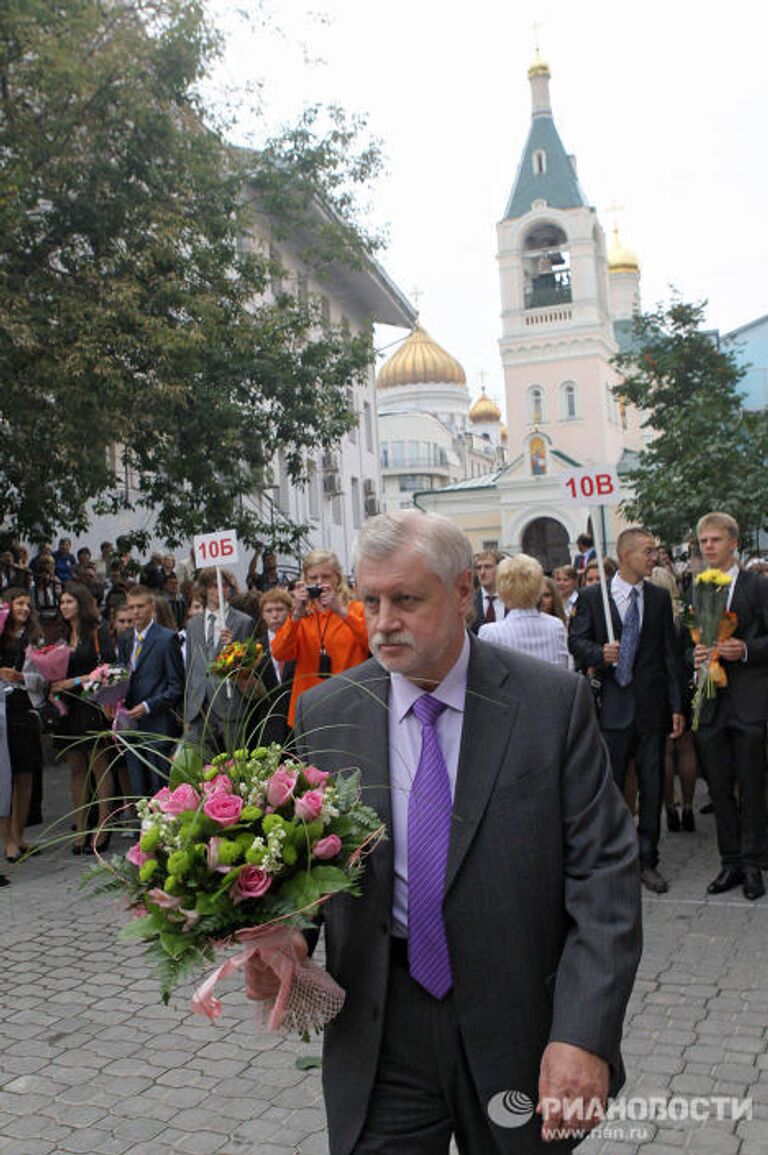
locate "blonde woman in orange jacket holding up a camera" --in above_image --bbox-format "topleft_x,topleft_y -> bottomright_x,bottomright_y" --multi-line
271,550 -> 368,725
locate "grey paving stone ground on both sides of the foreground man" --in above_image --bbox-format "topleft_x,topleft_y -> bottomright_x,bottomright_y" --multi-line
0,767 -> 768,1155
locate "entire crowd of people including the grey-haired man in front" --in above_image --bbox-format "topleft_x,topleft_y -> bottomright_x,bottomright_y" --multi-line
0,512 -> 768,1153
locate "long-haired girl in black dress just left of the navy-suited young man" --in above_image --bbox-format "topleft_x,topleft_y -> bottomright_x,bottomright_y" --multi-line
51,581 -> 114,855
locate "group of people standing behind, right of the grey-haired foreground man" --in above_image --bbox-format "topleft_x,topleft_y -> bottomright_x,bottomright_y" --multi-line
466,513 -> 768,900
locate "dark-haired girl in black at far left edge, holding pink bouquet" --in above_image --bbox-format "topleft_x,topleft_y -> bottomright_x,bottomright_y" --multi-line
0,586 -> 45,863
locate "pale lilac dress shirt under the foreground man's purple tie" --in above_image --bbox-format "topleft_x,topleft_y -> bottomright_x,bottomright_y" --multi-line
389,636 -> 469,937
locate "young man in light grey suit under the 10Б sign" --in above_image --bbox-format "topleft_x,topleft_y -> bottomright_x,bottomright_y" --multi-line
184,568 -> 254,752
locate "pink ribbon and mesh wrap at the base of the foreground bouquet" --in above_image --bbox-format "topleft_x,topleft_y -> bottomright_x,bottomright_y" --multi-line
192,922 -> 345,1034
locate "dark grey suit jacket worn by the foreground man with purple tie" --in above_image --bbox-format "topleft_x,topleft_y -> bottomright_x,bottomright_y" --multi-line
296,638 -> 641,1155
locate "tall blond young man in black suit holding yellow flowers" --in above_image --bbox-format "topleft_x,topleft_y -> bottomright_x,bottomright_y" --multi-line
694,513 -> 768,900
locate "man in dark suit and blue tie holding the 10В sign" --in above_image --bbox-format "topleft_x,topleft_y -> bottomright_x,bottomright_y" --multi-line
568,527 -> 685,894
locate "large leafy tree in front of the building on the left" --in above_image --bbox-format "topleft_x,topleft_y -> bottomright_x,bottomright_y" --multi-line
0,0 -> 375,545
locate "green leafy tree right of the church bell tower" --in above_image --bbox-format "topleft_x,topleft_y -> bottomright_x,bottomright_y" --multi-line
614,298 -> 768,542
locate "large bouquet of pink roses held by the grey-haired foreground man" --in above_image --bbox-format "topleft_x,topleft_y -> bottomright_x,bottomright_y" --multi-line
88,744 -> 383,1033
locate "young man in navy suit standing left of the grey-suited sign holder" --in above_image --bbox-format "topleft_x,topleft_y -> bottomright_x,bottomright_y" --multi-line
118,586 -> 184,798
